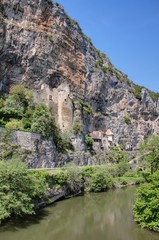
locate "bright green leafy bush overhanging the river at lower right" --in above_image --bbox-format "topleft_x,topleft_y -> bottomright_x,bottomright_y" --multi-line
134,171 -> 159,231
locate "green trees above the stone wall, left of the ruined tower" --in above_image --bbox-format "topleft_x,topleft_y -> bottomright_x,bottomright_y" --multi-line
0,85 -> 73,152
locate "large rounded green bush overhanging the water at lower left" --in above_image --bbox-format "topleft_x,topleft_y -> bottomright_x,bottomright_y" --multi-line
0,160 -> 44,221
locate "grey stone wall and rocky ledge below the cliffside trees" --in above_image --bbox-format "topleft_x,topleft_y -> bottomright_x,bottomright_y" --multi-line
0,128 -> 97,168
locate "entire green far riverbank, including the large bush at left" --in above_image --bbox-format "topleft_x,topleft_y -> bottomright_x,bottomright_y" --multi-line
0,159 -> 143,225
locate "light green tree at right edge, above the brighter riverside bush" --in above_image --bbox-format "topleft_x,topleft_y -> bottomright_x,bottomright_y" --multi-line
139,135 -> 159,173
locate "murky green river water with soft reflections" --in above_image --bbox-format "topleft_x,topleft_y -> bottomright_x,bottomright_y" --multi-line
0,187 -> 159,240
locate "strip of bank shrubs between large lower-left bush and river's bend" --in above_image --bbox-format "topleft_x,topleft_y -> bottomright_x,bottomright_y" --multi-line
36,164 -> 144,206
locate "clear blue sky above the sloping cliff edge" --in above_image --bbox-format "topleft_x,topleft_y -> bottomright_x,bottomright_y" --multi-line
56,0 -> 159,92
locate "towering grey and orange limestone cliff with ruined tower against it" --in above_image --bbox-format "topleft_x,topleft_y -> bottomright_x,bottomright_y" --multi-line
0,0 -> 159,150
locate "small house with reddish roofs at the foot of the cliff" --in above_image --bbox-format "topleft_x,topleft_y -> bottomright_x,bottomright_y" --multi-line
89,129 -> 114,150
